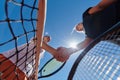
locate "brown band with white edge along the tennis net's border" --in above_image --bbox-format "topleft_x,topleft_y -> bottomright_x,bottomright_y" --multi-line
35,0 -> 47,80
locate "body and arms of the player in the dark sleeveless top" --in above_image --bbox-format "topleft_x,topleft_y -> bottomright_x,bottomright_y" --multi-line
54,0 -> 120,61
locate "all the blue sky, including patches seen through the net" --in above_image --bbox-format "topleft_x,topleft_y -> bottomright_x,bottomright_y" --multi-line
0,0 -> 100,80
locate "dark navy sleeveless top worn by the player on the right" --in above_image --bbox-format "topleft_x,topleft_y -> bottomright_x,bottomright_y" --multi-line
83,0 -> 120,39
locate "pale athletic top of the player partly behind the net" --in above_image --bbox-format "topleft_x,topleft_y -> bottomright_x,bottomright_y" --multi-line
3,41 -> 45,77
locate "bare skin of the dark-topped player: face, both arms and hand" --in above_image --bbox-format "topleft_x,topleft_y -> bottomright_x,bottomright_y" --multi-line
56,0 -> 118,62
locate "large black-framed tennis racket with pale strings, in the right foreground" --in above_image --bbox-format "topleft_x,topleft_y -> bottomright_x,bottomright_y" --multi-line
68,22 -> 120,80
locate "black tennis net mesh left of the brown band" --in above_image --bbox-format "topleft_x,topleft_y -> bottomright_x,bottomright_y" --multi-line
0,0 -> 39,80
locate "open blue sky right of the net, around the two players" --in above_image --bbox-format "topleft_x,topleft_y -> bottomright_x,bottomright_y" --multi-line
40,0 -> 99,80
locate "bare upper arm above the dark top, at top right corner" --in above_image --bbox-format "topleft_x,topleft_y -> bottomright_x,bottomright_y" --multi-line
88,0 -> 117,14
